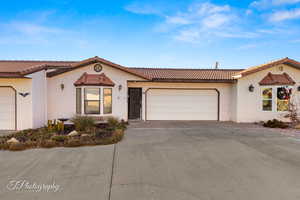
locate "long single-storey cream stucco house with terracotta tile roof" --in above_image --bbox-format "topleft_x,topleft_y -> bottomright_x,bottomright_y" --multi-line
0,57 -> 300,130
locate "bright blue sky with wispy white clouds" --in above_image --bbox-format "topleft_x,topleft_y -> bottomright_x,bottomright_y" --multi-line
0,0 -> 300,68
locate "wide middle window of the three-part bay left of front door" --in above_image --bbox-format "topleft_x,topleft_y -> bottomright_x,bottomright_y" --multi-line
84,88 -> 100,114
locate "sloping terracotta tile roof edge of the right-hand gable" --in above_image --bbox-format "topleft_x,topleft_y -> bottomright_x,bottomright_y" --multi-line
235,57 -> 300,76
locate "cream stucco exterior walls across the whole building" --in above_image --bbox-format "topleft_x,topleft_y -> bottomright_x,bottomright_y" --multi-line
0,56 -> 300,130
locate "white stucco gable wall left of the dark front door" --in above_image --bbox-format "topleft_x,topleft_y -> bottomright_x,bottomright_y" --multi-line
47,64 -> 143,120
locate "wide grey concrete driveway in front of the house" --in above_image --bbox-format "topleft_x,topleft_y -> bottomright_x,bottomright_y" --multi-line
0,122 -> 300,200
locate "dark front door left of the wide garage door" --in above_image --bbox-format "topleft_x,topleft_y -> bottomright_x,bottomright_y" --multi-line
128,88 -> 142,119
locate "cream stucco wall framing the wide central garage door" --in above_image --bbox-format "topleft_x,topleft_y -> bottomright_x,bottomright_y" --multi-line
128,82 -> 233,121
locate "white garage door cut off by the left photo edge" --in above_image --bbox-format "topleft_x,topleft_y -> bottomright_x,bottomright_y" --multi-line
0,87 -> 15,130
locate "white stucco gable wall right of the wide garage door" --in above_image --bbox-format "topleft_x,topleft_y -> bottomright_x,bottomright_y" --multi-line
237,65 -> 300,122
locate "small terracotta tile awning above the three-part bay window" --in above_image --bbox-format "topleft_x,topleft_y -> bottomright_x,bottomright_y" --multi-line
74,73 -> 115,86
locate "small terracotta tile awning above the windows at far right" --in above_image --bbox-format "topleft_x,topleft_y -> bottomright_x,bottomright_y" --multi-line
259,73 -> 295,85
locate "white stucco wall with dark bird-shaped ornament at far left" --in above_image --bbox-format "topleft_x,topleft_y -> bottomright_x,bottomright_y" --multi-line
0,78 -> 32,130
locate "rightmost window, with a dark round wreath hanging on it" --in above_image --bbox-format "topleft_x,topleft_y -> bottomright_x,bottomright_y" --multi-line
277,87 -> 292,111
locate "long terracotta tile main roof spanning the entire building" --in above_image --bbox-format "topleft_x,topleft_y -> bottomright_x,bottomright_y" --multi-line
0,56 -> 300,82
